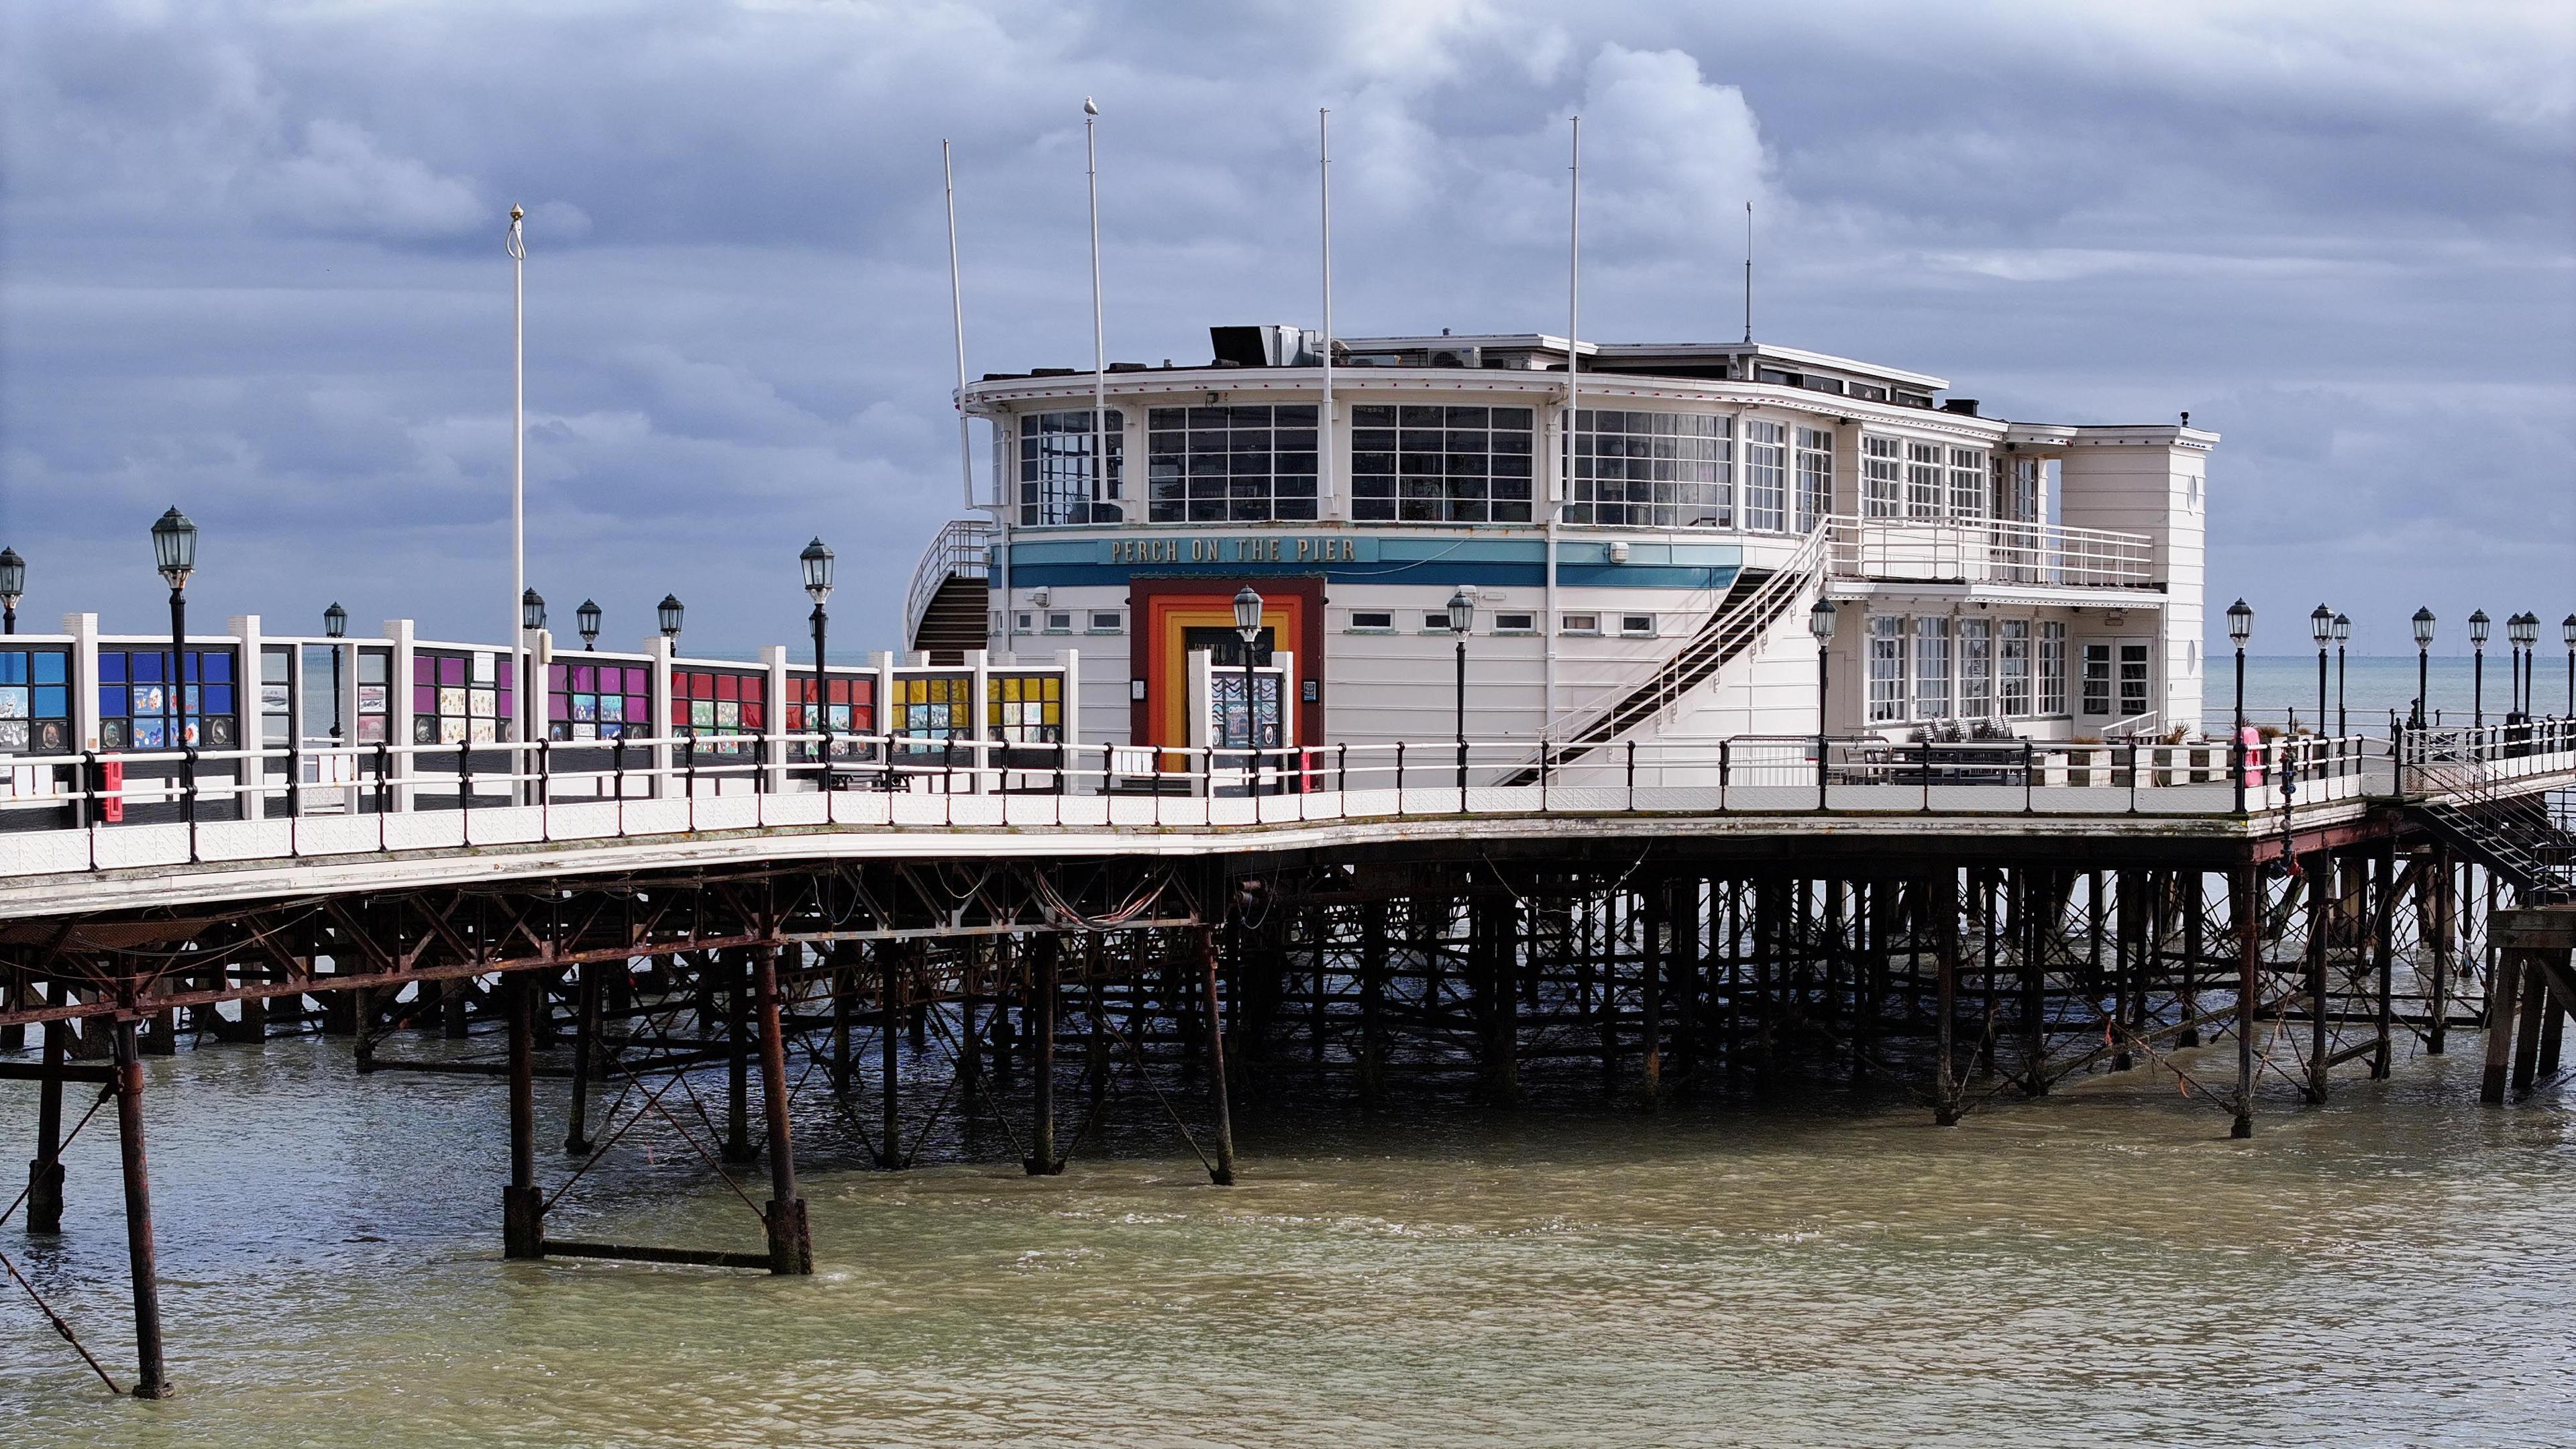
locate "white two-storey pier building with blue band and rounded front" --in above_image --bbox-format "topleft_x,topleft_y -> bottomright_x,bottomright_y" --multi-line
904,327 -> 2218,753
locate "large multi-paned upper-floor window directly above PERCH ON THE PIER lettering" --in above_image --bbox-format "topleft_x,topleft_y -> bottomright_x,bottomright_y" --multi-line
1146,402 -> 1316,523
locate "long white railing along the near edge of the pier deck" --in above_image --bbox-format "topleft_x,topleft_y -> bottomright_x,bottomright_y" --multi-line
0,722 -> 2504,895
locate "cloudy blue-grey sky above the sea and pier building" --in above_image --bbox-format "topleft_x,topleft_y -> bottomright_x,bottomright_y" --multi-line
0,0 -> 2576,652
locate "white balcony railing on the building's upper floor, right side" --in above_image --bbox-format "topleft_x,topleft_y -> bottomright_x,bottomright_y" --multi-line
1827,516 -> 2156,588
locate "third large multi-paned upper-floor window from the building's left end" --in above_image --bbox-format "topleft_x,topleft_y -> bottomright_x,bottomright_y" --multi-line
1350,405 -> 1536,523
